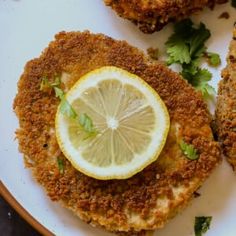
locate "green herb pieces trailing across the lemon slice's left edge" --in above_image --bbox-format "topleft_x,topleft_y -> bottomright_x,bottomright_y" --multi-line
40,77 -> 98,136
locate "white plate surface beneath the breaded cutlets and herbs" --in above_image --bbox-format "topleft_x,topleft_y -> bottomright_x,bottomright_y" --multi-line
0,0 -> 236,236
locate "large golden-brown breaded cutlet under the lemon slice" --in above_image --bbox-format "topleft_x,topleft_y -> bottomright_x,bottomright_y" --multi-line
14,31 -> 220,233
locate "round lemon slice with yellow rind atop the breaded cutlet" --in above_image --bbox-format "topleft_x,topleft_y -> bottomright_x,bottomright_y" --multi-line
56,67 -> 170,179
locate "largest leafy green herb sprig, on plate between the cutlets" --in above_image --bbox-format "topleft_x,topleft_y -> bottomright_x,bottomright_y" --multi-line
166,19 -> 221,96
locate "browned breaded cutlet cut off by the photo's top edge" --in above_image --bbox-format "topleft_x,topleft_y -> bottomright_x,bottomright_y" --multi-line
104,0 -> 227,33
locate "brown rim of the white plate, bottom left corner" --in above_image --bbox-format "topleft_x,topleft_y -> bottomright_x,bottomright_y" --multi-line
0,180 -> 54,236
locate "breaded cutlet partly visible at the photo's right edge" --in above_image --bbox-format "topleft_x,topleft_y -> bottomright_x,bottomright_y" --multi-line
216,25 -> 236,170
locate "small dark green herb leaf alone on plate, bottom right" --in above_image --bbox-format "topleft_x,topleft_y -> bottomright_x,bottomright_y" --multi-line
194,216 -> 212,236
